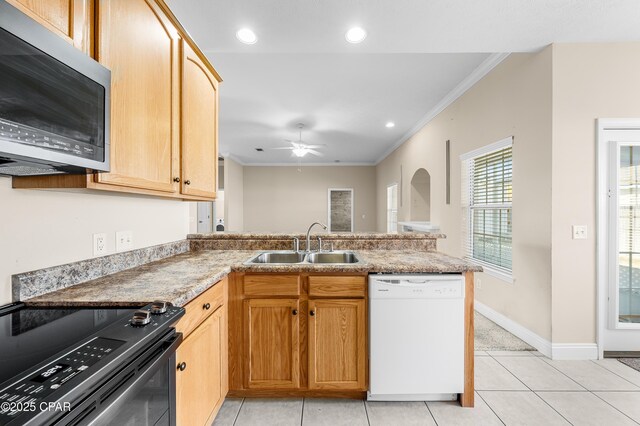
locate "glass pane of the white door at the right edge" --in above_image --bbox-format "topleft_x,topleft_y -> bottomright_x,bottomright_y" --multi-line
615,144 -> 640,324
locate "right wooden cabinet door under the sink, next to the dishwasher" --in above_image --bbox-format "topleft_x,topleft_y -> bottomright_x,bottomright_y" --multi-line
308,299 -> 367,390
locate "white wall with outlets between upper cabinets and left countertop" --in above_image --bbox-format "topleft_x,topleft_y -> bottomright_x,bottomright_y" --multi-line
0,177 -> 190,305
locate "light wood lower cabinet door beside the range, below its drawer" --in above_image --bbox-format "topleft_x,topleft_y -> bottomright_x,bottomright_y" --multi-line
176,307 -> 226,426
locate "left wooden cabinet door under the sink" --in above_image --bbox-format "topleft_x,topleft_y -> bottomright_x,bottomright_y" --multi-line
244,299 -> 300,389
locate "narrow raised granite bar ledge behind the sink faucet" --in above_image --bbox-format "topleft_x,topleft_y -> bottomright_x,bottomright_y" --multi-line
187,233 -> 447,240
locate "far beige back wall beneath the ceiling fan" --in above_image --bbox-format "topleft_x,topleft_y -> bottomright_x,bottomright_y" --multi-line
244,166 -> 376,232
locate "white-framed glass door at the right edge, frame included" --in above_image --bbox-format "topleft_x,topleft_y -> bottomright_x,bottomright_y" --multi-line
596,125 -> 640,357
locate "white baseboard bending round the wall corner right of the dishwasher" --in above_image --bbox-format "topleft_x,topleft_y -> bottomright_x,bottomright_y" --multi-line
474,300 -> 598,360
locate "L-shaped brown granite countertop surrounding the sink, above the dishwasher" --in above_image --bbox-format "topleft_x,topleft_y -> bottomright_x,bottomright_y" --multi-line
25,250 -> 482,306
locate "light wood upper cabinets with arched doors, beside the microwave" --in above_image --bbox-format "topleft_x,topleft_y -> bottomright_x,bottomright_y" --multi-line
12,0 -> 222,201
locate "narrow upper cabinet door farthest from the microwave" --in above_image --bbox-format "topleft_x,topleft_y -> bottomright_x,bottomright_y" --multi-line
180,41 -> 218,198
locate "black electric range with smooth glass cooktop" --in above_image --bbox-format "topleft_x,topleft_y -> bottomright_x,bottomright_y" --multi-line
0,302 -> 184,425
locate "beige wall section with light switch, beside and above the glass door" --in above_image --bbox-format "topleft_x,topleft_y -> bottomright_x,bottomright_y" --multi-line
552,43 -> 640,342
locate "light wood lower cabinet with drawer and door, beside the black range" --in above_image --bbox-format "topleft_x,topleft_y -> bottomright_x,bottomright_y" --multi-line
176,280 -> 228,426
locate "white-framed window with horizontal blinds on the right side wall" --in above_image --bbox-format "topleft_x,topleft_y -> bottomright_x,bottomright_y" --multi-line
460,137 -> 513,279
